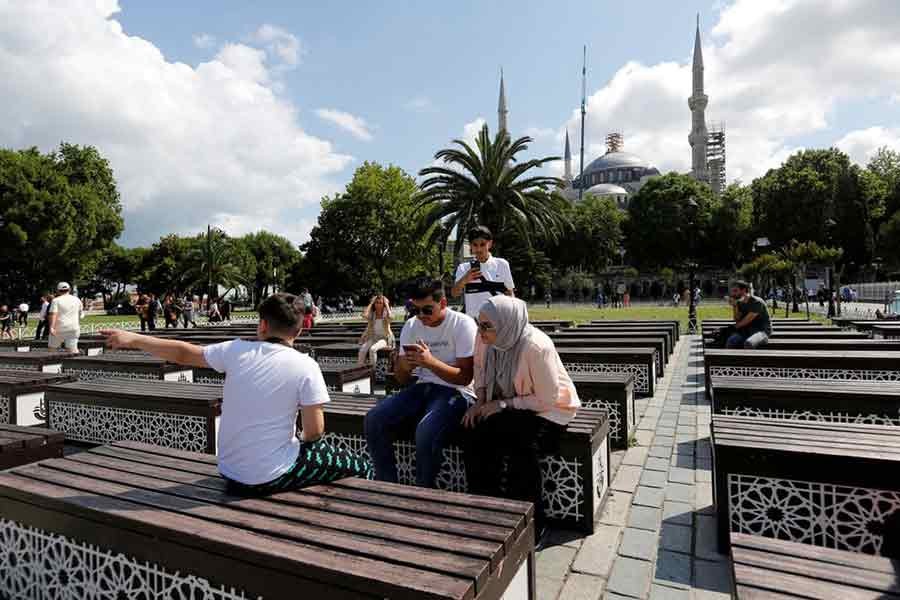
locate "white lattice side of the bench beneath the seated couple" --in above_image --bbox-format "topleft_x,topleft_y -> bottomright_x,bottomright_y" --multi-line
324,433 -> 592,520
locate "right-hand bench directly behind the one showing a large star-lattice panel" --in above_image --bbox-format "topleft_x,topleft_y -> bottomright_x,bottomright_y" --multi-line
712,377 -> 900,426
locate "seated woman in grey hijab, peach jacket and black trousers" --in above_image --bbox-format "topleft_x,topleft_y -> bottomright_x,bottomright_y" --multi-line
463,296 -> 581,532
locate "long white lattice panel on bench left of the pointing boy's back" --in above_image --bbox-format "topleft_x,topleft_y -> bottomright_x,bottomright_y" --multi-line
48,402 -> 206,452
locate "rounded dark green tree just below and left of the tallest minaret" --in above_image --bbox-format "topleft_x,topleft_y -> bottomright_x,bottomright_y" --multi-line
625,173 -> 715,268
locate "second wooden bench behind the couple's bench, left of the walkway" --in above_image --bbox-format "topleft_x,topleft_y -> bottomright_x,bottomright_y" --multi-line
556,347 -> 657,397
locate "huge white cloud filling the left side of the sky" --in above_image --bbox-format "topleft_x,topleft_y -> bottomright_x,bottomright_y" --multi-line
0,0 -> 352,244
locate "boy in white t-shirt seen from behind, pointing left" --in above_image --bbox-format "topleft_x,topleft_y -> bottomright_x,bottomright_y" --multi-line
100,293 -> 372,496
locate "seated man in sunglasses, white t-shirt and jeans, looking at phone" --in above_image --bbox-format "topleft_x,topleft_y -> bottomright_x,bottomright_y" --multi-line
365,279 -> 477,487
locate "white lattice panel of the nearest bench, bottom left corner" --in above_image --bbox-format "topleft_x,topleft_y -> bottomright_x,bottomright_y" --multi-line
0,519 -> 250,600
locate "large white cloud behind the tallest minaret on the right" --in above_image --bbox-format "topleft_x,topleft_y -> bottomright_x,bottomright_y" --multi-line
558,0 -> 900,182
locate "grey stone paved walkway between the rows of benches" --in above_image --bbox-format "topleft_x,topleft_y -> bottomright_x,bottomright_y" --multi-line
537,336 -> 731,600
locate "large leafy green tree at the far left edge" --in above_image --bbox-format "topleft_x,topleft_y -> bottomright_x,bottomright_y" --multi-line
0,144 -> 123,299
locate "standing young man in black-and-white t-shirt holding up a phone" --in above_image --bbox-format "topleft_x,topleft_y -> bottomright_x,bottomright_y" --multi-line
452,225 -> 516,319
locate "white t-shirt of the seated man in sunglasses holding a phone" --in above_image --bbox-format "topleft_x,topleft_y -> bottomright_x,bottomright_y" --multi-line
400,309 -> 478,398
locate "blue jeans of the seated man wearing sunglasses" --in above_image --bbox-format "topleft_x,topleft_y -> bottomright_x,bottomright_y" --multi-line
365,383 -> 469,487
